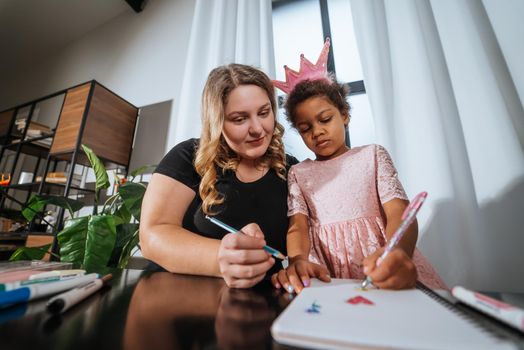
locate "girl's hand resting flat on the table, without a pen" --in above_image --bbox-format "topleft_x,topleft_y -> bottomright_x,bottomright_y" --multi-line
271,256 -> 331,293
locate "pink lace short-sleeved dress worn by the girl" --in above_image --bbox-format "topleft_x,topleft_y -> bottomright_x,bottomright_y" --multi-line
288,145 -> 446,288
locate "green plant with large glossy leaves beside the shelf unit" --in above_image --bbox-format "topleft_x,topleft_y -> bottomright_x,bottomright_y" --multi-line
10,145 -> 152,270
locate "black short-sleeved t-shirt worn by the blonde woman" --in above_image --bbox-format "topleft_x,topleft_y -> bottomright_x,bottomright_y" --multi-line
155,139 -> 298,273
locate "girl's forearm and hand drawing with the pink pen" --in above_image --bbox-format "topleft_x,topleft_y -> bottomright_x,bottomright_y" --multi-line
363,198 -> 418,289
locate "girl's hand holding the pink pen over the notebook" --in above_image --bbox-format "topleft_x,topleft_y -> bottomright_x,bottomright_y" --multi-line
363,247 -> 417,289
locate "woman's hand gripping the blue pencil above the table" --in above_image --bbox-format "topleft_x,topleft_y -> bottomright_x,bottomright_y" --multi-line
218,224 -> 275,288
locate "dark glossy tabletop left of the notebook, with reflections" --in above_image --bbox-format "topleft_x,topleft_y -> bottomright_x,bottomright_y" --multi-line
0,270 -> 291,350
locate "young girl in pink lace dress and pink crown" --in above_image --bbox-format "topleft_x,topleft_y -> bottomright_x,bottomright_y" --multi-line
272,41 -> 445,292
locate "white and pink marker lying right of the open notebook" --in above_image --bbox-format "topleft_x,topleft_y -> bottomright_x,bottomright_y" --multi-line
451,286 -> 524,332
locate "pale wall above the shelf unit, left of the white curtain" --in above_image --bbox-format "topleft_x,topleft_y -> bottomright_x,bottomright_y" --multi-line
0,0 -> 195,110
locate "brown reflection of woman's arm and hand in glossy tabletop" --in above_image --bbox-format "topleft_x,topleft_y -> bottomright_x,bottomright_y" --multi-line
123,272 -> 290,349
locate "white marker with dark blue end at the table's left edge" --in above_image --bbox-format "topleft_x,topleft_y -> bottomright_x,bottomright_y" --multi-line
0,273 -> 98,308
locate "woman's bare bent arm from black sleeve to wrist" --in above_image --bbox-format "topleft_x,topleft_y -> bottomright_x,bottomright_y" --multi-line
140,174 -> 221,276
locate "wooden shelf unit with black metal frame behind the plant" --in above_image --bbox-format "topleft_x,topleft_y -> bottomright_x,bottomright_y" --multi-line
0,80 -> 139,253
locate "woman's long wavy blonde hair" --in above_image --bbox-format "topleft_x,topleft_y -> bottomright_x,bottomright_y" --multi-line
194,64 -> 286,215
